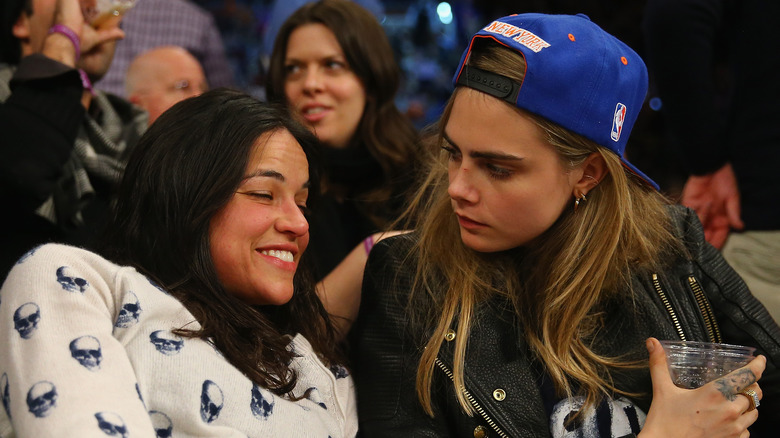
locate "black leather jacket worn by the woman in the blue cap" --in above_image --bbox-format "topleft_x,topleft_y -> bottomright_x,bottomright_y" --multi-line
352,207 -> 780,438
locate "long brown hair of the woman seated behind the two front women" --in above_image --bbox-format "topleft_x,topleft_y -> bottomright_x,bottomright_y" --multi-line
266,0 -> 420,226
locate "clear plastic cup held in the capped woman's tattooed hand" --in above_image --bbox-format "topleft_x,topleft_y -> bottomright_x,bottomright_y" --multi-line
660,341 -> 756,389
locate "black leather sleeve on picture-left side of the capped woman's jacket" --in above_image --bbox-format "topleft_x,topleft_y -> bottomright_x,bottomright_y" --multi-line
351,235 -> 449,438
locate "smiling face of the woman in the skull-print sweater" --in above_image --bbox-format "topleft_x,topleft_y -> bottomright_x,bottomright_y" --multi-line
209,130 -> 309,305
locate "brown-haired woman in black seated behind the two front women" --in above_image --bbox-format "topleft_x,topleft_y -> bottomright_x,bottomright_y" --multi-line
267,0 -> 419,330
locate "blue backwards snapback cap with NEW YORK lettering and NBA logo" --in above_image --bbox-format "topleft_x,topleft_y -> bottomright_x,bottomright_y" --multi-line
453,13 -> 658,190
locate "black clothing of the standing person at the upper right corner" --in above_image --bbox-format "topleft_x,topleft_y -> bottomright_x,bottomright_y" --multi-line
642,0 -> 780,231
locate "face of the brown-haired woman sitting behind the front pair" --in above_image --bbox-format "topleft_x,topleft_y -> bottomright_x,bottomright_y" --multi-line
284,23 -> 366,148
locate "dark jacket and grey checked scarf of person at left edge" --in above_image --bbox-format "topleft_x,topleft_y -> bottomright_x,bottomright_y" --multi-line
0,54 -> 148,283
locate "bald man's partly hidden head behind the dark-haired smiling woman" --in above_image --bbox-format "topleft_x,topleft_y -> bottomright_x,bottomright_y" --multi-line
126,47 -> 208,123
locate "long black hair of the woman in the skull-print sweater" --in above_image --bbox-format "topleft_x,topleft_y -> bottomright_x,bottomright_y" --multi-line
102,89 -> 339,395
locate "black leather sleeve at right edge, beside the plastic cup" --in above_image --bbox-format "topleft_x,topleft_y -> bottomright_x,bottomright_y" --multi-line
681,209 -> 780,438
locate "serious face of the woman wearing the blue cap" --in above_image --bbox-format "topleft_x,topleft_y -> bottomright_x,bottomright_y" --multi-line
443,88 -> 581,252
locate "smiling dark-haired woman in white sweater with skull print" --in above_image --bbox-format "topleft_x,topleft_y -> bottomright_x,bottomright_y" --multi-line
0,89 -> 357,437
